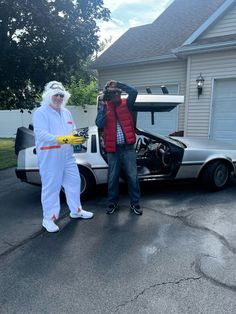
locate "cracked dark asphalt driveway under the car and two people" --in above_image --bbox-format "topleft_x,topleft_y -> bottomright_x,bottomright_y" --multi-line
0,169 -> 236,314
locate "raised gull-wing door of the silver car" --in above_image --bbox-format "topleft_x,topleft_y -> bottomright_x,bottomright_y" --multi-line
133,94 -> 184,124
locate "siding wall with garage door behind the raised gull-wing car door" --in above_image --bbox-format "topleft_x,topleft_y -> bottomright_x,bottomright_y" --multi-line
99,61 -> 186,134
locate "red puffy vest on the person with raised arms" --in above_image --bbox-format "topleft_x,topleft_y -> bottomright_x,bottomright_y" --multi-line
104,99 -> 136,153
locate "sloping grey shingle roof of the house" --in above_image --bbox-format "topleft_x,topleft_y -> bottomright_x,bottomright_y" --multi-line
93,0 -> 226,68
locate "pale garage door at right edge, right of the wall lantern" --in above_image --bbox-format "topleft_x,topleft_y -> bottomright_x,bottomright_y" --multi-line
210,78 -> 236,144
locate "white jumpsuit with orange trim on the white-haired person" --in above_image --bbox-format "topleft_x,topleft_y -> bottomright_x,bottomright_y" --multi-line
33,104 -> 81,219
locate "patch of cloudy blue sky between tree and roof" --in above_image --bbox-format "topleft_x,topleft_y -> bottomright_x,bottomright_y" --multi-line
99,0 -> 174,47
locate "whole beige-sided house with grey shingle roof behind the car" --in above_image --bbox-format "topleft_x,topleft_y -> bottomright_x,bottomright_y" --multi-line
94,0 -> 236,143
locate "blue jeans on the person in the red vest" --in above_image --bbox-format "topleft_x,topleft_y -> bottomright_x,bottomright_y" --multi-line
107,144 -> 140,204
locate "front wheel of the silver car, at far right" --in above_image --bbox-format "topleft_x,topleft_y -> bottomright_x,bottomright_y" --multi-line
201,161 -> 230,191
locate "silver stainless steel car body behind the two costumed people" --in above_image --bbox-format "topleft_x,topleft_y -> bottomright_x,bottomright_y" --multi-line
16,126 -> 236,193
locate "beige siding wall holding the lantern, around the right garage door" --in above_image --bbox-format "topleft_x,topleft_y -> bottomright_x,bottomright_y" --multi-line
185,50 -> 236,141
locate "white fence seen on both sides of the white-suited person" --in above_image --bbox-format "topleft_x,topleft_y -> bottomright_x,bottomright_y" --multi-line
0,105 -> 97,138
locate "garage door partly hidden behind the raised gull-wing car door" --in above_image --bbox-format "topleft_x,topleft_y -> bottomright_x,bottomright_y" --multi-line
137,85 -> 178,135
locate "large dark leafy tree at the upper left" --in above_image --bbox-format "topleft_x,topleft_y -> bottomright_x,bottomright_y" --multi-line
0,0 -> 110,109
